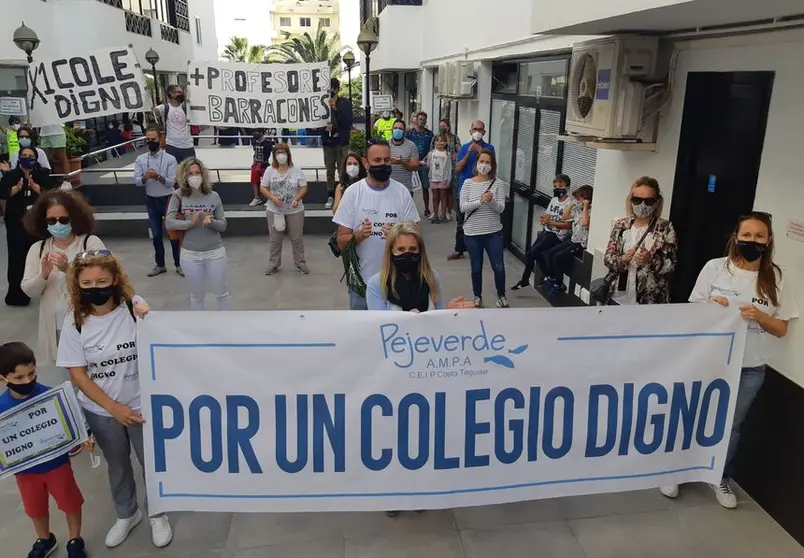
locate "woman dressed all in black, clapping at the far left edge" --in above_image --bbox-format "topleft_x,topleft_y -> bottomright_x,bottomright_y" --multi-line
0,146 -> 53,306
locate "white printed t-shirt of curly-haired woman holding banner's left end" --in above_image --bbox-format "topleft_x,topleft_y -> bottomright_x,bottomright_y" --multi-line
56,304 -> 140,417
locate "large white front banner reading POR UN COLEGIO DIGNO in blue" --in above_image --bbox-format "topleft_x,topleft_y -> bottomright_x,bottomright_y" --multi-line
138,304 -> 746,513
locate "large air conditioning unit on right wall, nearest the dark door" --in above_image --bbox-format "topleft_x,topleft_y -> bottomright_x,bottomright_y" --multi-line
565,37 -> 659,139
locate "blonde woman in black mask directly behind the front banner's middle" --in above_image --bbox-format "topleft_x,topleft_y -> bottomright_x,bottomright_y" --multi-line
366,221 -> 474,313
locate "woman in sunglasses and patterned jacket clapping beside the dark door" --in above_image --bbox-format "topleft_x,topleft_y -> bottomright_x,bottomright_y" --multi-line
603,176 -> 677,305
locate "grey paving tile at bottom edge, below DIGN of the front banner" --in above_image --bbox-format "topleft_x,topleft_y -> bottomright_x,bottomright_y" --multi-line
569,511 -> 700,558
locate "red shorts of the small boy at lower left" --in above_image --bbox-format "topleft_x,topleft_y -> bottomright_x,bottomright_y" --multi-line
16,463 -> 84,517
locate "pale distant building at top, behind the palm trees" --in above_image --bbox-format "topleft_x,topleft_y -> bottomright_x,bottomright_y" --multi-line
271,0 -> 341,44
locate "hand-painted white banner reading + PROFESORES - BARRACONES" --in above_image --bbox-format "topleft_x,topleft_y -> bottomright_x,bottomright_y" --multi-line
187,61 -> 330,128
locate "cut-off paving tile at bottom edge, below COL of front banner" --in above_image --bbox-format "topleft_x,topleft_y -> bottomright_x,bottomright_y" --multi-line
346,531 -> 464,558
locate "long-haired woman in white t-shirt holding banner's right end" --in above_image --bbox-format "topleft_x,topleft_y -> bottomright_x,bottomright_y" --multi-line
661,212 -> 799,508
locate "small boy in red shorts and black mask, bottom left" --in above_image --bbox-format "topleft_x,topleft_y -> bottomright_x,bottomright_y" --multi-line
0,342 -> 91,558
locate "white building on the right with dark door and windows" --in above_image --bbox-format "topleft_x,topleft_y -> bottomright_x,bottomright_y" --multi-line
361,0 -> 804,543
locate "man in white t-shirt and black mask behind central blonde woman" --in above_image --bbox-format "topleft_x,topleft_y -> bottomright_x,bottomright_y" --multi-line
332,140 -> 419,310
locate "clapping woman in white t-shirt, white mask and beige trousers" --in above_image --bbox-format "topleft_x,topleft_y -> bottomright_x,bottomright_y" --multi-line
260,143 -> 310,275
